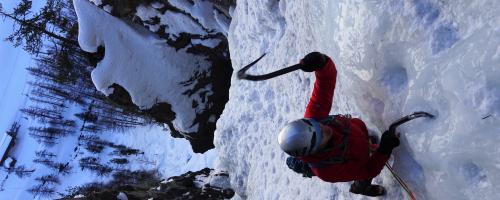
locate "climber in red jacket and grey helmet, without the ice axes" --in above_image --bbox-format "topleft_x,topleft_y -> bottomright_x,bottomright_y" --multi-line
278,52 -> 399,196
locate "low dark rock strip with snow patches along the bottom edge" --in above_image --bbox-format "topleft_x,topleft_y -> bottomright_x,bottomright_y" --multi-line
63,168 -> 234,200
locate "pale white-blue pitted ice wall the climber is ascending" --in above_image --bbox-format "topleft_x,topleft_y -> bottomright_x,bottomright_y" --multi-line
215,0 -> 500,199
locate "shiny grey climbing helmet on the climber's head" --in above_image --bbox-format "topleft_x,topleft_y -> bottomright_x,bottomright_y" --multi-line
278,118 -> 321,157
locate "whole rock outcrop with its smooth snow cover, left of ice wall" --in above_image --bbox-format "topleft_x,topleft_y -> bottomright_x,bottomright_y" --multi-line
74,0 -> 232,152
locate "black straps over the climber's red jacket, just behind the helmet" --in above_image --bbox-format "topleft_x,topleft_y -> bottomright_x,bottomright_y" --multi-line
308,115 -> 351,168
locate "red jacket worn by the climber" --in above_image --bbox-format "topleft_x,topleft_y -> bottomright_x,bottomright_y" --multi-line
299,58 -> 390,182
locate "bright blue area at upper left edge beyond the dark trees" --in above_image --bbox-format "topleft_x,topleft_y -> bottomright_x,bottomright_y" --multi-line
0,0 -> 44,132
